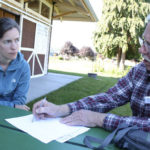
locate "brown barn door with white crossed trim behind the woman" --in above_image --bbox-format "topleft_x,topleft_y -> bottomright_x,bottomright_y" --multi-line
21,16 -> 50,77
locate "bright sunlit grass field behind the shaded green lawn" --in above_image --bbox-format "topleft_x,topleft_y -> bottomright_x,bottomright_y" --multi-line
49,56 -> 136,78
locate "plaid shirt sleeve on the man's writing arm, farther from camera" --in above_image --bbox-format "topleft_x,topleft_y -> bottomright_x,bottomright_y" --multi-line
68,66 -> 133,113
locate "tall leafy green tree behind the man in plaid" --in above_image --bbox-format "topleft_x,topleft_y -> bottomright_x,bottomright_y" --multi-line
94,0 -> 150,69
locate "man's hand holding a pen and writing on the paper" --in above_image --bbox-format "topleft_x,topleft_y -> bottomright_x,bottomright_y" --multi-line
32,100 -> 70,119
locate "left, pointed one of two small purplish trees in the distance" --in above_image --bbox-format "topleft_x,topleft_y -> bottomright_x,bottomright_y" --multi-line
60,41 -> 79,56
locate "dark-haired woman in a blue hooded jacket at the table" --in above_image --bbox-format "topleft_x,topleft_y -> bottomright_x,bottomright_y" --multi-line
0,18 -> 30,110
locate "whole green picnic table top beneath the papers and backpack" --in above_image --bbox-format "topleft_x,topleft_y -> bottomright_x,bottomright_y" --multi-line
0,106 -> 122,150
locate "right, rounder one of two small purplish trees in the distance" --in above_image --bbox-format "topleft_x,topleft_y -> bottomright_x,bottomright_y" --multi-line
79,46 -> 95,60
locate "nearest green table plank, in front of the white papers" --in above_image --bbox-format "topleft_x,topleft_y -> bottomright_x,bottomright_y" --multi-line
0,127 -> 88,150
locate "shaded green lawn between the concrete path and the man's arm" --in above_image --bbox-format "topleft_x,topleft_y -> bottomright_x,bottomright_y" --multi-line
28,70 -> 131,116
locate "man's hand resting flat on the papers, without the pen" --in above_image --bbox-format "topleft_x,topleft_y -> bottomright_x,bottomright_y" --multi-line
61,110 -> 106,127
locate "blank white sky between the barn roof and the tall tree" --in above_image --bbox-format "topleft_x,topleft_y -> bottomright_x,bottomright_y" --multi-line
51,0 -> 102,52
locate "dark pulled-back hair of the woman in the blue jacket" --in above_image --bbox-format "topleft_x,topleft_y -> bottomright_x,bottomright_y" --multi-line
0,18 -> 20,38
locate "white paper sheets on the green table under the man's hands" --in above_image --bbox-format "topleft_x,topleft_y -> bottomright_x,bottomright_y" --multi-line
5,114 -> 89,143
